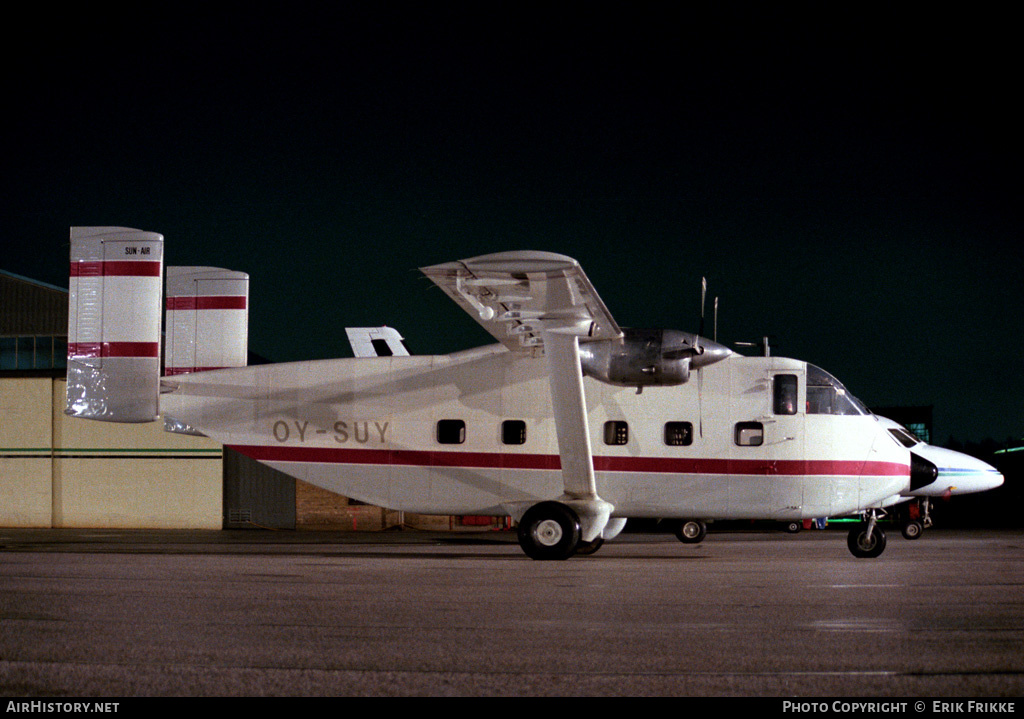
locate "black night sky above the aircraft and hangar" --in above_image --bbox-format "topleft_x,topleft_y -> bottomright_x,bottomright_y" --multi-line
0,2 -> 1024,443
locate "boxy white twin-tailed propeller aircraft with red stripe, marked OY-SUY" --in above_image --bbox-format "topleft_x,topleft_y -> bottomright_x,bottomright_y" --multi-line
66,227 -> 950,559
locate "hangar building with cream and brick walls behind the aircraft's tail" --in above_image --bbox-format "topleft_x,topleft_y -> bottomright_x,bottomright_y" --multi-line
0,270 -> 489,531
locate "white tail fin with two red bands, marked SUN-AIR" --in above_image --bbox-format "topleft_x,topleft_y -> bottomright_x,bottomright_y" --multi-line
65,227 -> 164,422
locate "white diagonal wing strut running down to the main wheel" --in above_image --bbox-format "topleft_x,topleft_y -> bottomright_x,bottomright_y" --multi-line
543,323 -> 614,542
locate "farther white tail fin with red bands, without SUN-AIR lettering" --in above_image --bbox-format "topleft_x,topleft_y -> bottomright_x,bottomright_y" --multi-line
164,267 -> 249,376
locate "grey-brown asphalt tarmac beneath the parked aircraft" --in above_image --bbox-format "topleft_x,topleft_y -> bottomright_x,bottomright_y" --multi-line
0,530 -> 1024,700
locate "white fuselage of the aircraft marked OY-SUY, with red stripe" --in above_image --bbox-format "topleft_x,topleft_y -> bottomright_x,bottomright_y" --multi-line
161,345 -> 909,519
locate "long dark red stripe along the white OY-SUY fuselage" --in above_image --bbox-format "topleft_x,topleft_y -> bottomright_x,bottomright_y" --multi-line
229,445 -> 910,476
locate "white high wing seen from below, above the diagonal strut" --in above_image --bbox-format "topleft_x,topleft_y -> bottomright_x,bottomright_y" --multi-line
421,251 -> 623,351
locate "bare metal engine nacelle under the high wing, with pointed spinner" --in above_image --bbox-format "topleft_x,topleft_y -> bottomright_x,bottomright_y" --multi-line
580,328 -> 731,387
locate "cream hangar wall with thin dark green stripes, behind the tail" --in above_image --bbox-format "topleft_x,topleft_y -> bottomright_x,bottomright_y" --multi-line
0,377 -> 223,530
